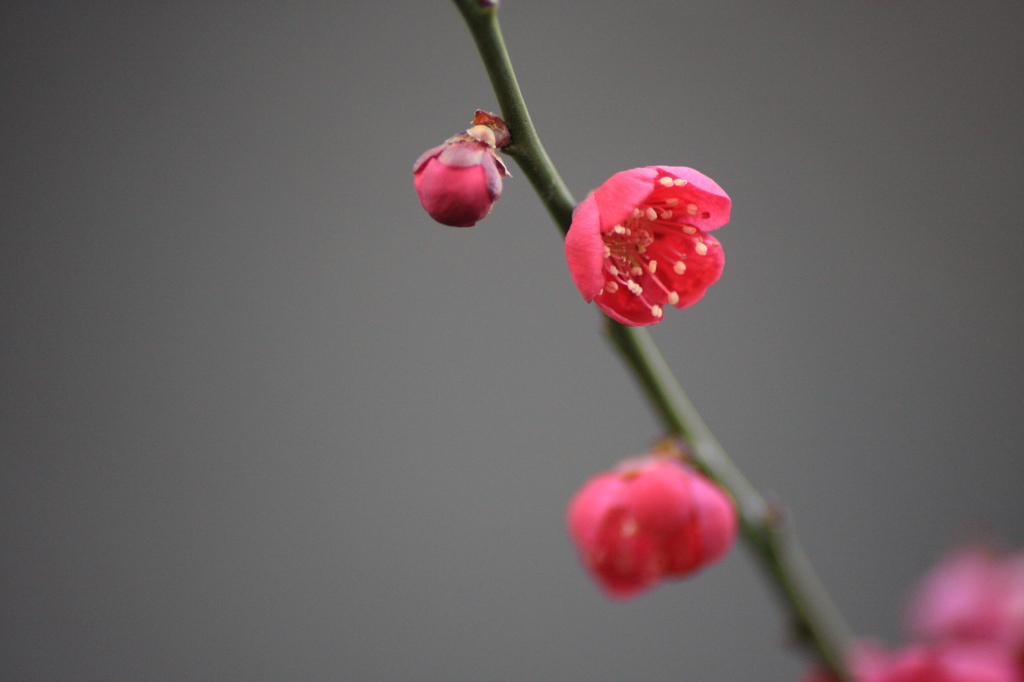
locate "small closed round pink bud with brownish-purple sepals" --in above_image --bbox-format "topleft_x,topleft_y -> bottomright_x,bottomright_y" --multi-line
413,111 -> 510,227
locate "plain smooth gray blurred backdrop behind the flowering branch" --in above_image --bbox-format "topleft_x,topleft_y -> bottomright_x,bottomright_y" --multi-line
0,0 -> 1024,682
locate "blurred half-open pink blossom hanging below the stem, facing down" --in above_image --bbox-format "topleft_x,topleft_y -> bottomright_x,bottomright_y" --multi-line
568,455 -> 737,598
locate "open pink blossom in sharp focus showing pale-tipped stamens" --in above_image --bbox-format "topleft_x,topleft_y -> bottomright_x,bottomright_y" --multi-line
565,166 -> 732,326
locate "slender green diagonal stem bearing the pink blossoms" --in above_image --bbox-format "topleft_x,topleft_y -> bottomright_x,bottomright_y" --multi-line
454,0 -> 851,682
